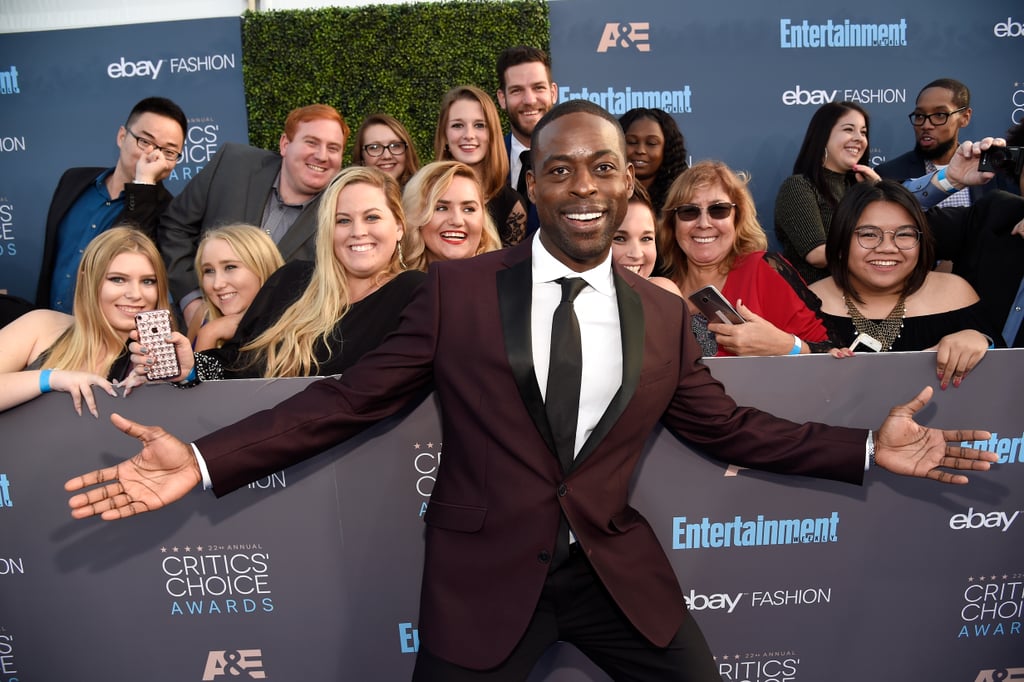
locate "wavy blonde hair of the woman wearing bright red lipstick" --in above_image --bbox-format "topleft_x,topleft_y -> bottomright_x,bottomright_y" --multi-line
401,161 -> 502,271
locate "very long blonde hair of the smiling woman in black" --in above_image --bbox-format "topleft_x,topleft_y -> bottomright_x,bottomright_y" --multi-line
242,166 -> 406,377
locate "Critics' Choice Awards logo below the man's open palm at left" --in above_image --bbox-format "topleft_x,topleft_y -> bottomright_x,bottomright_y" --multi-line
159,543 -> 274,617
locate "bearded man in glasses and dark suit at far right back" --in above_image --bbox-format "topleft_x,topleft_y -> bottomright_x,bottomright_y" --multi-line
874,78 -> 1015,208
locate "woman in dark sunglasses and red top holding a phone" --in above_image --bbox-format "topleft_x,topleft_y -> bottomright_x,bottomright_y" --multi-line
658,161 -> 831,355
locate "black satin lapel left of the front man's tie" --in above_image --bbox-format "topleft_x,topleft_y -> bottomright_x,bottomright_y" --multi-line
497,258 -> 555,452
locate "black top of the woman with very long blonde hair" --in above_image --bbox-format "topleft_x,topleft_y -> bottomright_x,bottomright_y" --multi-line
196,261 -> 426,380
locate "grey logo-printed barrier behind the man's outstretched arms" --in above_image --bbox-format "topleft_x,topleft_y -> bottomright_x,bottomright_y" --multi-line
0,350 -> 1024,682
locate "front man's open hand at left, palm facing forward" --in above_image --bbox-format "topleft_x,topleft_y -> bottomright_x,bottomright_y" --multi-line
65,414 -> 203,521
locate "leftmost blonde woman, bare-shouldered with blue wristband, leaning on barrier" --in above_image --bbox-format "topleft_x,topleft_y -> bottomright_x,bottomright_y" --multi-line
0,227 -> 170,416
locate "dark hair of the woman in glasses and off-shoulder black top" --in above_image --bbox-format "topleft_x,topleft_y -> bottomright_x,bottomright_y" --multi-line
825,180 -> 935,303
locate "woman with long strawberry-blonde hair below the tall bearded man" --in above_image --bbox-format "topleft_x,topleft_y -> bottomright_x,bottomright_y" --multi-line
434,85 -> 526,246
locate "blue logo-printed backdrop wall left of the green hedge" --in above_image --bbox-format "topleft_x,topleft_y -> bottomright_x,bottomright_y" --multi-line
0,17 -> 249,300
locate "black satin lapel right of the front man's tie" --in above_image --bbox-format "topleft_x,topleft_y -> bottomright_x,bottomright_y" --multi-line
572,272 -> 644,469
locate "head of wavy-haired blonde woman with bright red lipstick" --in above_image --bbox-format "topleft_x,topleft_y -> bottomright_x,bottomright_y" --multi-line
401,161 -> 502,271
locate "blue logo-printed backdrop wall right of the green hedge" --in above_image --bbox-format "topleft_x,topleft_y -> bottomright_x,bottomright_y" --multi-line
551,0 -> 1024,244
